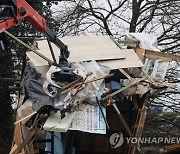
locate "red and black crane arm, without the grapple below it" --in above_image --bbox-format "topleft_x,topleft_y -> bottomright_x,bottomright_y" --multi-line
0,0 -> 70,62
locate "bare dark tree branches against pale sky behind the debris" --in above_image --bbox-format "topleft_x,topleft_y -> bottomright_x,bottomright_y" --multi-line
54,0 -> 180,111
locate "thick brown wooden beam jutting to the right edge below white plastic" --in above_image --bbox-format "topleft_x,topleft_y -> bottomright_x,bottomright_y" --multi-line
145,50 -> 180,62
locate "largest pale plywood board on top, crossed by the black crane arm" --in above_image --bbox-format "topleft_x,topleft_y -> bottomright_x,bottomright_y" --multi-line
37,36 -> 123,61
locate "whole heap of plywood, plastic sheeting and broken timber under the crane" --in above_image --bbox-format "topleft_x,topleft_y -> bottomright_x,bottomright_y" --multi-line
11,36 -> 180,154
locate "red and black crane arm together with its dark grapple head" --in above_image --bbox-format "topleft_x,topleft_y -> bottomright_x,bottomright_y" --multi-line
0,0 -> 78,82
